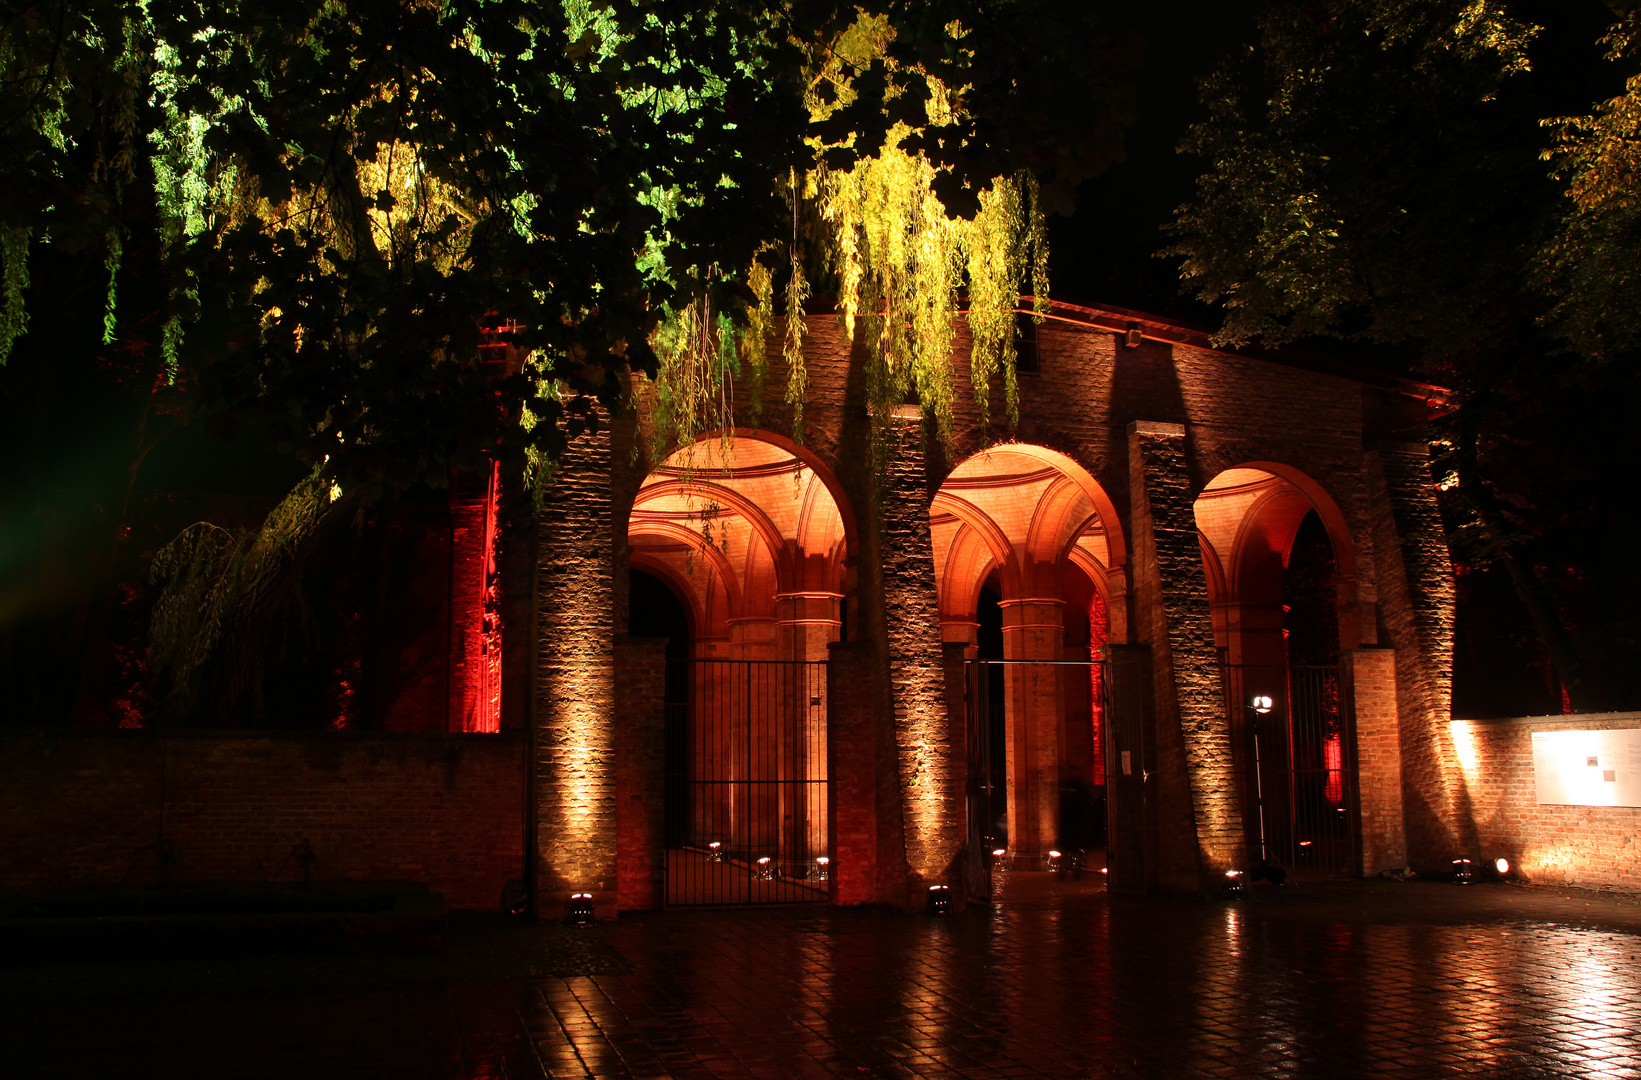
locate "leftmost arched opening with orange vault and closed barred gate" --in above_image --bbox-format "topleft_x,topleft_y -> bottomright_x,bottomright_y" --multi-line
627,432 -> 853,904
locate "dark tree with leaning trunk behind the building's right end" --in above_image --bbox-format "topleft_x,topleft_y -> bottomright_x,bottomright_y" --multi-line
1168,0 -> 1634,707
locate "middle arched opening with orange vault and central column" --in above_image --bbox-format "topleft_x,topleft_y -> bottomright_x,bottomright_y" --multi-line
930,443 -> 1127,868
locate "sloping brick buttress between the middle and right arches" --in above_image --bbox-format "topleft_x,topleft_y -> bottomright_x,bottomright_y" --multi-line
1129,422 -> 1242,891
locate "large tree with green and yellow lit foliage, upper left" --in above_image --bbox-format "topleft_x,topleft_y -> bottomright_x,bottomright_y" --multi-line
0,0 -> 1124,722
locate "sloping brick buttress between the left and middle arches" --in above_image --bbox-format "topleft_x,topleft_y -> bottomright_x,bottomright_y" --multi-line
878,428 -> 967,903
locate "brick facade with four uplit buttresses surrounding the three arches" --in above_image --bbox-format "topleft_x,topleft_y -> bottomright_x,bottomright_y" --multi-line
574,306 -> 1465,903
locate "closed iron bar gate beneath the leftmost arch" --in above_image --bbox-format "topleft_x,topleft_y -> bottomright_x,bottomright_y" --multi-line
665,660 -> 832,906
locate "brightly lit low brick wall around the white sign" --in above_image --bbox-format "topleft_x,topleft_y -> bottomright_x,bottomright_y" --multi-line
1452,712 -> 1641,890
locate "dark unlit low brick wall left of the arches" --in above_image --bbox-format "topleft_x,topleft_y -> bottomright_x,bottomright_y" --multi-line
0,730 -> 523,909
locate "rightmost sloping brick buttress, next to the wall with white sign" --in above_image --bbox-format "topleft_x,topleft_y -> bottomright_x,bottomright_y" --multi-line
1365,443 -> 1475,872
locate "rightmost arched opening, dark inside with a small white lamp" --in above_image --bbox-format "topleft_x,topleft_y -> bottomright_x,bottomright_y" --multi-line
1196,464 -> 1359,872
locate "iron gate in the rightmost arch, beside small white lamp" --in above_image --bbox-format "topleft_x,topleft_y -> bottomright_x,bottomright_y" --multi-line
1224,665 -> 1357,873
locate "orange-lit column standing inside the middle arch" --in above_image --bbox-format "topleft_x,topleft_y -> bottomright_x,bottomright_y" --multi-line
1003,597 -> 1065,870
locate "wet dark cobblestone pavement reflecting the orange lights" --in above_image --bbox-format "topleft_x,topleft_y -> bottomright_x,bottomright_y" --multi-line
9,883 -> 1641,1080
